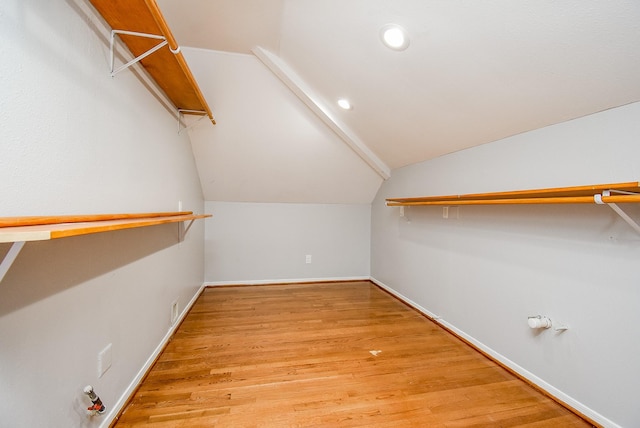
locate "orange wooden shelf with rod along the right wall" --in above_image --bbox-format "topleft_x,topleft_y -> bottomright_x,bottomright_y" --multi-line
386,182 -> 640,207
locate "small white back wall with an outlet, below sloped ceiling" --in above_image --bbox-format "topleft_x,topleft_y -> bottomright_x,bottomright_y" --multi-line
205,201 -> 371,284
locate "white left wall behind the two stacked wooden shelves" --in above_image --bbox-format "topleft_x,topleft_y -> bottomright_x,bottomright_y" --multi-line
0,0 -> 204,427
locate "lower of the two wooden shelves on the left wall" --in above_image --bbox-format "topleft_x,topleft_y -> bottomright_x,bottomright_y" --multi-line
0,211 -> 211,242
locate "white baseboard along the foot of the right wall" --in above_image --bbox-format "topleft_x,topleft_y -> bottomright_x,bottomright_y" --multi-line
370,278 -> 622,428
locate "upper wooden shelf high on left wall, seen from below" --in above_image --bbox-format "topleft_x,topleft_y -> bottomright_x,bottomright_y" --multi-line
90,0 -> 216,125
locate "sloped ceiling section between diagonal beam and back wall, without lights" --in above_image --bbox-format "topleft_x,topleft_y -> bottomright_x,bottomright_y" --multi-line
183,48 -> 382,203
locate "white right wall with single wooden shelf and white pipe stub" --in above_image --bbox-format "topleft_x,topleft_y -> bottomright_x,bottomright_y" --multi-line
371,103 -> 640,427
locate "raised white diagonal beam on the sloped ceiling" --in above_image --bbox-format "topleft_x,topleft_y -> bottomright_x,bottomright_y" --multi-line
251,46 -> 391,180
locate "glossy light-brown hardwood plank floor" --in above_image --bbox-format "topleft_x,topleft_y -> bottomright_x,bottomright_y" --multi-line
115,282 -> 591,428
